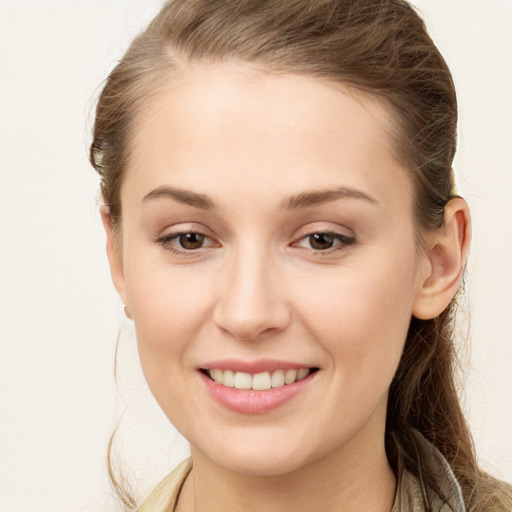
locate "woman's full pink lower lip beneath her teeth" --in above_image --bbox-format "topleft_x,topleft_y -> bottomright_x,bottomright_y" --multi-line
199,372 -> 318,414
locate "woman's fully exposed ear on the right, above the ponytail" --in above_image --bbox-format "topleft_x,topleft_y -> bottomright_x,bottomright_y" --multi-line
412,197 -> 471,320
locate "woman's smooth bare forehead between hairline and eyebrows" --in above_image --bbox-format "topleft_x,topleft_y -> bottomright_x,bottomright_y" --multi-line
125,63 -> 411,212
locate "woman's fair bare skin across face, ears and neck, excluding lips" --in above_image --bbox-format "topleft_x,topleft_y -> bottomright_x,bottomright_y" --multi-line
103,64 -> 469,512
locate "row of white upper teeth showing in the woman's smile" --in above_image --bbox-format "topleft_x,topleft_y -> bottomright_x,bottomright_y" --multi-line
208,368 -> 311,391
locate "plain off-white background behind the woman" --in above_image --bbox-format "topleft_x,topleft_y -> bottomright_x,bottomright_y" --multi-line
0,0 -> 512,512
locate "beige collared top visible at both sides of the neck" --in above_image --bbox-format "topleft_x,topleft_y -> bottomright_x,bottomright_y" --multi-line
138,438 -> 466,512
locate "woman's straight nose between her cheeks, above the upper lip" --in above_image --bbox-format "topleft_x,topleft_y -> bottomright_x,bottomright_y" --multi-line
214,249 -> 291,340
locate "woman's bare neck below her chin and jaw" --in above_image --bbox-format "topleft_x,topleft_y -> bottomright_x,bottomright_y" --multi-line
176,420 -> 396,512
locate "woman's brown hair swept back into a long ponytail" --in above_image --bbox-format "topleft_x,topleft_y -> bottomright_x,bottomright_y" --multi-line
90,0 -> 511,512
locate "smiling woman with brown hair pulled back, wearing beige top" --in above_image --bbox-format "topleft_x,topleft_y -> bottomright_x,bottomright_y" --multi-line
91,0 -> 512,512
